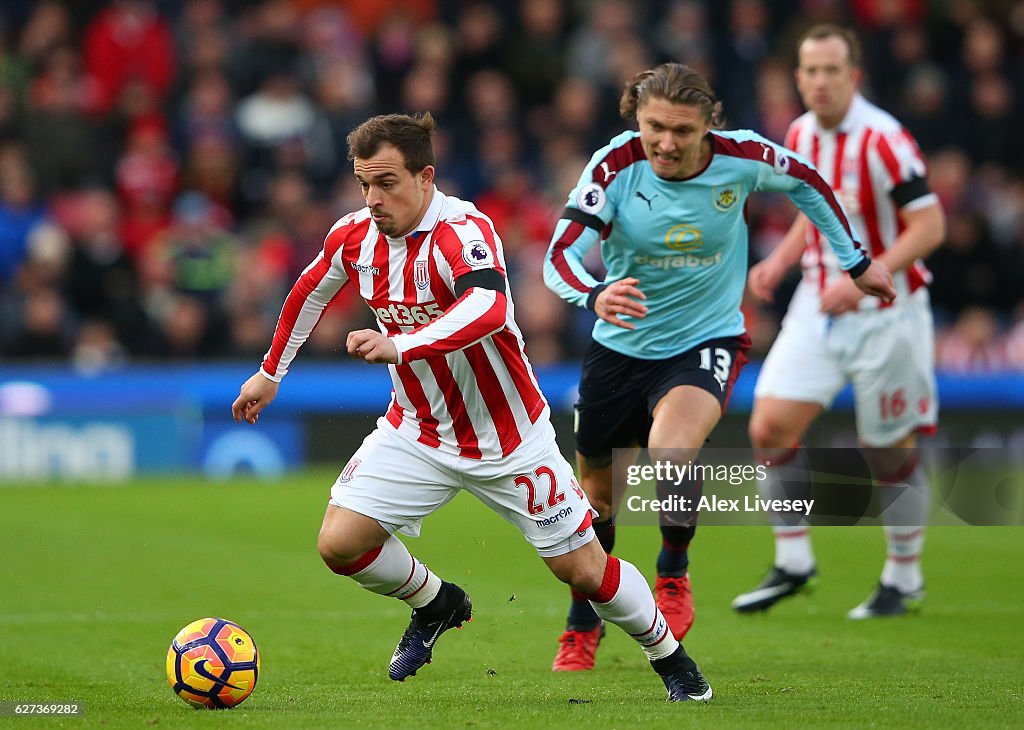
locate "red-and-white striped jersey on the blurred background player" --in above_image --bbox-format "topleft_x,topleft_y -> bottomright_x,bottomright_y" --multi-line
785,94 -> 939,309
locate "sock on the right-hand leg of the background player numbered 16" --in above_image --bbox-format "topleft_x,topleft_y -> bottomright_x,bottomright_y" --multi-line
879,454 -> 932,593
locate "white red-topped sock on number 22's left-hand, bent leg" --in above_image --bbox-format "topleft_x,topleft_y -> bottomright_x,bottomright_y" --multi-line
335,534 -> 441,608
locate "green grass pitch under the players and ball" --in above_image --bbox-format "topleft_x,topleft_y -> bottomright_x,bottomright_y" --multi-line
0,471 -> 1024,729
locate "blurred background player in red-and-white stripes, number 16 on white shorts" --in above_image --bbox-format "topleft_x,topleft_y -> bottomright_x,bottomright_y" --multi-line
733,25 -> 945,618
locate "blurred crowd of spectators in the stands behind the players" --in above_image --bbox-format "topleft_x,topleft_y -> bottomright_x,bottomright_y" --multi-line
0,0 -> 1024,373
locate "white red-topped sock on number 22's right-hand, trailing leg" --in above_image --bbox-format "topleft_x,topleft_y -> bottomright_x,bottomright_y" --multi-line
588,555 -> 679,661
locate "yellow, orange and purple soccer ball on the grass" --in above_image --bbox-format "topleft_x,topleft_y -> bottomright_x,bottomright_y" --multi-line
167,618 -> 259,710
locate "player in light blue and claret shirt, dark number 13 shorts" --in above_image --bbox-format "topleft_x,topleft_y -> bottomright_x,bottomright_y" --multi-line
544,63 -> 895,671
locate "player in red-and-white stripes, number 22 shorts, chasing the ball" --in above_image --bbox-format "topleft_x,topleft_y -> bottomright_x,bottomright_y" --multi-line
231,115 -> 712,701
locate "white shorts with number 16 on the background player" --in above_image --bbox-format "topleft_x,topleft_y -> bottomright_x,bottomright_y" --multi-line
754,283 -> 938,446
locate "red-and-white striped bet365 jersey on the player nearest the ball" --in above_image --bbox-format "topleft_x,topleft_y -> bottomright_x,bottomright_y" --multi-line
262,188 -> 548,460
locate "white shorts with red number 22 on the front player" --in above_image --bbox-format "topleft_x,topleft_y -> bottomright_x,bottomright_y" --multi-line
331,418 -> 596,557
